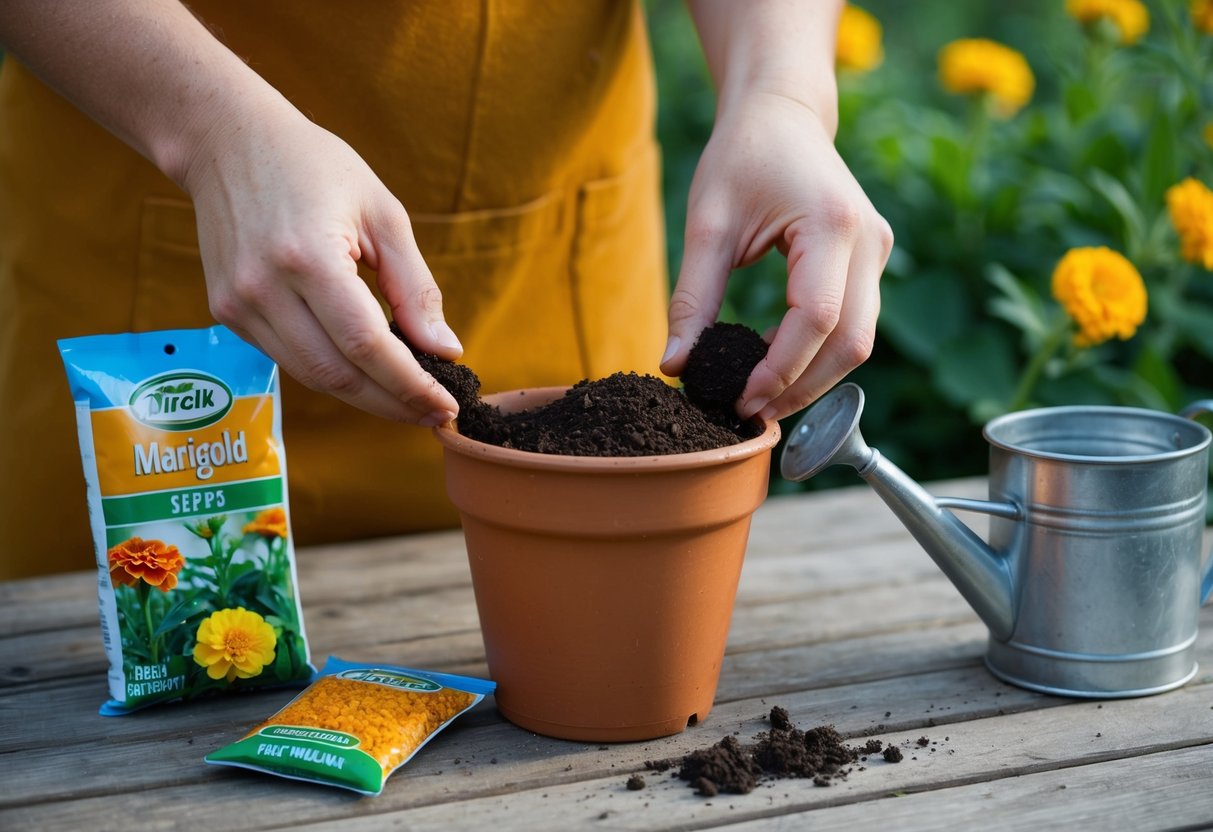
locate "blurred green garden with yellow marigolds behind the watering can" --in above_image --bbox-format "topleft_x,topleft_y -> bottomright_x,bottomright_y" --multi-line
647,0 -> 1213,490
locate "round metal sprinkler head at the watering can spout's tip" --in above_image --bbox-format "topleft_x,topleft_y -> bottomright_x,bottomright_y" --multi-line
780,382 -> 878,483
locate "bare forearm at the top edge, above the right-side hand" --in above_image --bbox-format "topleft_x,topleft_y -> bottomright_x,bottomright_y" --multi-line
688,0 -> 843,136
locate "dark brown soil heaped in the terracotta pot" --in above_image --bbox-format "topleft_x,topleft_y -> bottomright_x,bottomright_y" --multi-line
392,321 -> 762,456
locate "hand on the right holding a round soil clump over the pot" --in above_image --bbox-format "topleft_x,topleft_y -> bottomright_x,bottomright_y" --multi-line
661,92 -> 893,420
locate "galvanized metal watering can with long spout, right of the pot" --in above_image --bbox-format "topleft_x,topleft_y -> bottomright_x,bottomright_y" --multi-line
781,383 -> 1213,699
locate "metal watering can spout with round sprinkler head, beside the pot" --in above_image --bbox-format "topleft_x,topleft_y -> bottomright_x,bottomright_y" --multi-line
780,383 -> 1021,640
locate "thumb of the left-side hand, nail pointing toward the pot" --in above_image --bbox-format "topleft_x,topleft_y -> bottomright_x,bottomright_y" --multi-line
365,200 -> 463,361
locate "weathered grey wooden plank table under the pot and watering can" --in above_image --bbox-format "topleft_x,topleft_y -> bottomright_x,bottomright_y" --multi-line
0,480 -> 1213,832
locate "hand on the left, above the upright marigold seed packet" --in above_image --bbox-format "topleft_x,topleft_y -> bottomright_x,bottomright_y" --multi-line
181,107 -> 463,427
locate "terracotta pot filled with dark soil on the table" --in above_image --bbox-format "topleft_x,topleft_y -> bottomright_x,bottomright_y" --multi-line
435,387 -> 779,742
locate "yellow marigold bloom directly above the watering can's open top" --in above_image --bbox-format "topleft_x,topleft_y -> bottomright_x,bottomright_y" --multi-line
1053,246 -> 1146,347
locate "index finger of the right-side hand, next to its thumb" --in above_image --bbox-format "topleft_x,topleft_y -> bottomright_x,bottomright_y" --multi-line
738,222 -> 854,418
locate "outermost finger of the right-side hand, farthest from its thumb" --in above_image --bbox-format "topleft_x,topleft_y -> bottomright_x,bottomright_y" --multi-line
742,221 -> 893,420
